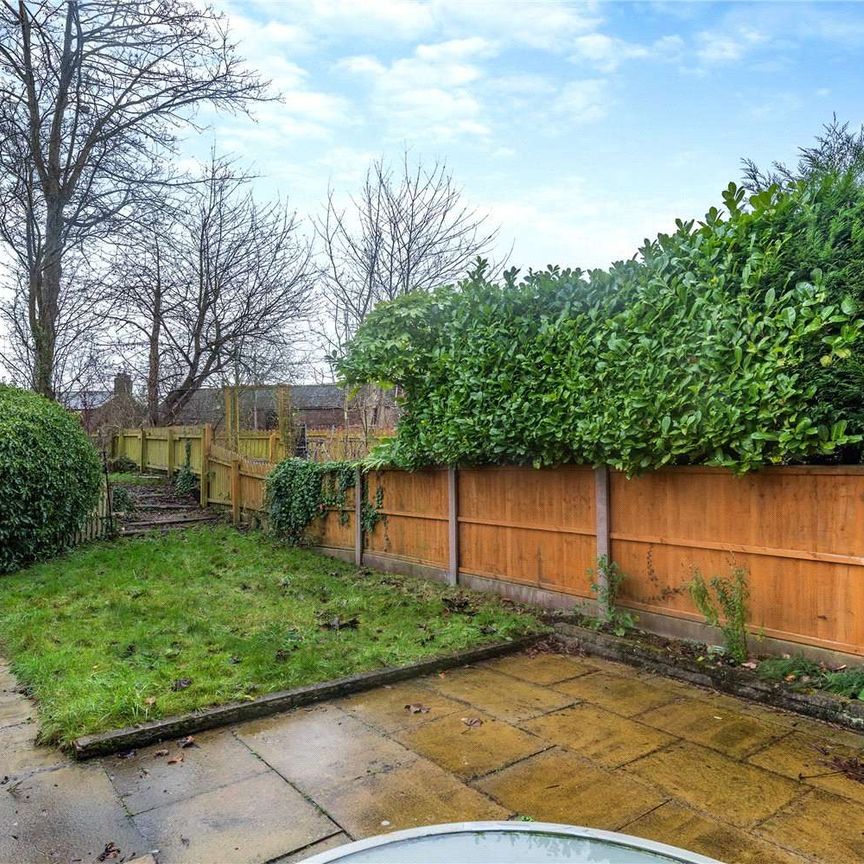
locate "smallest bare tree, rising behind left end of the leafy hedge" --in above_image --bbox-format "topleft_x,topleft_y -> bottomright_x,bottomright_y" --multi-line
316,153 -> 498,349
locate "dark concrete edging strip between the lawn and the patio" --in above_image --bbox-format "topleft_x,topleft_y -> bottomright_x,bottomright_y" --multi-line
72,633 -> 548,759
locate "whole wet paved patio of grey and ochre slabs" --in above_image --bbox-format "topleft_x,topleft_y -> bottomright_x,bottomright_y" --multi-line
0,654 -> 864,864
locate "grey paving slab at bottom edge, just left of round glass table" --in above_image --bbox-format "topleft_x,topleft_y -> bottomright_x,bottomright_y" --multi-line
132,771 -> 339,864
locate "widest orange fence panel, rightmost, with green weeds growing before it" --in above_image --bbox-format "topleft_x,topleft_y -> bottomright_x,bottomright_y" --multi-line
611,466 -> 864,653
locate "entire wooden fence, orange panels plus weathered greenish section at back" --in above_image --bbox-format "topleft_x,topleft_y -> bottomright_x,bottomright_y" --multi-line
115,427 -> 864,655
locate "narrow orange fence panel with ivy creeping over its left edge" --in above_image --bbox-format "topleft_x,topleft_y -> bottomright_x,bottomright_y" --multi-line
366,470 -> 448,568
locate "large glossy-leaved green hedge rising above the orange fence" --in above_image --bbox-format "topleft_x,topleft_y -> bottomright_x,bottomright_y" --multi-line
340,177 -> 864,473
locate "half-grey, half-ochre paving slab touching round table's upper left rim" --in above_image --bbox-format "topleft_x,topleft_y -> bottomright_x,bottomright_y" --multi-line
316,759 -> 511,838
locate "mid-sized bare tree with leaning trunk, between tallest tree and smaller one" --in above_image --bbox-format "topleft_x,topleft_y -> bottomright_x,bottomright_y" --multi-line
112,157 -> 314,423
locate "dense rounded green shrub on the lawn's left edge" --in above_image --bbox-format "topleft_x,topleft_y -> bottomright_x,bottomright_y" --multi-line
0,385 -> 101,573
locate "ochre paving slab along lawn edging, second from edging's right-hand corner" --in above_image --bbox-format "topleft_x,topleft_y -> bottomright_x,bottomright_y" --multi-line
427,668 -> 574,723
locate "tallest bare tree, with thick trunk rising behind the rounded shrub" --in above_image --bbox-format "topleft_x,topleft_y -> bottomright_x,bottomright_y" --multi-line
0,0 -> 263,396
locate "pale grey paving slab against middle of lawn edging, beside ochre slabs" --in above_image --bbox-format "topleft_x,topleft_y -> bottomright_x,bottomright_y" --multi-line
236,705 -> 417,796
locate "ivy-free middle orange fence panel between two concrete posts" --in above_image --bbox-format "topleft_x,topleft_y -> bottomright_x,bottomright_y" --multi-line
458,466 -> 596,597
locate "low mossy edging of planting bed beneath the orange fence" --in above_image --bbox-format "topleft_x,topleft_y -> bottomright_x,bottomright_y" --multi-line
554,622 -> 864,732
